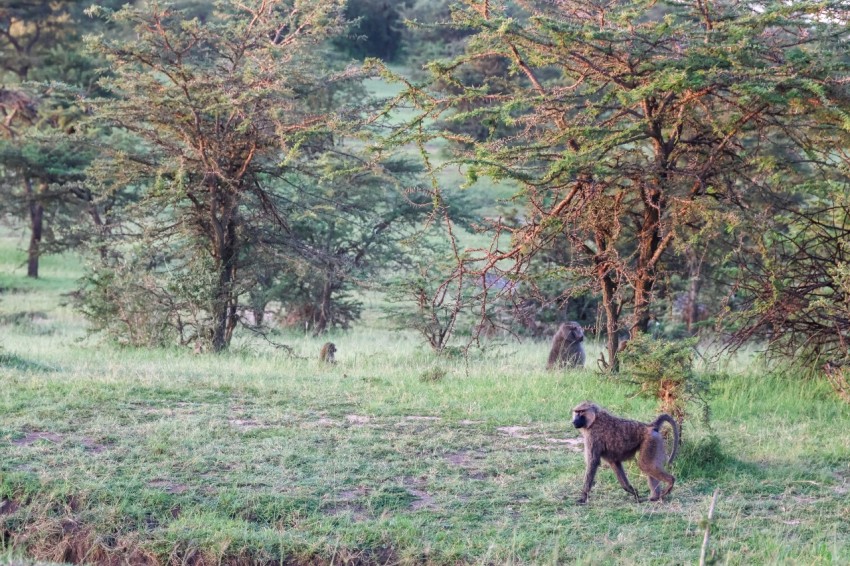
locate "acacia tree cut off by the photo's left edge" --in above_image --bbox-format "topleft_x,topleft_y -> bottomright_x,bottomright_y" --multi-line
0,0 -> 109,278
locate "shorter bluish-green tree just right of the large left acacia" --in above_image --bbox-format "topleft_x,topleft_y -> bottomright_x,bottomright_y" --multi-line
242,156 -> 431,334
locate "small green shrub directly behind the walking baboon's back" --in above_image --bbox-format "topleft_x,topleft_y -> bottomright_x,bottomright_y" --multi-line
620,334 -> 710,425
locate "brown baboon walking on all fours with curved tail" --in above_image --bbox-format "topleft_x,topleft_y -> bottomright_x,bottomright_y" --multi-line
573,401 -> 679,504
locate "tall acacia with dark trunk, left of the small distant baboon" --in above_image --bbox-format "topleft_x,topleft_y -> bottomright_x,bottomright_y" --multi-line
83,0 -> 356,351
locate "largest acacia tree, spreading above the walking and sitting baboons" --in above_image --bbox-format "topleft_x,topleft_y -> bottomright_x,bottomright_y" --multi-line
380,0 -> 847,365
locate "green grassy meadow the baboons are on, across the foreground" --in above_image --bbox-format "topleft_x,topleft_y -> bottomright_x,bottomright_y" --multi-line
0,233 -> 850,564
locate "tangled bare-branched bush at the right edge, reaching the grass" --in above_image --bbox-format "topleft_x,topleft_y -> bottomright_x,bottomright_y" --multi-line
727,202 -> 850,380
